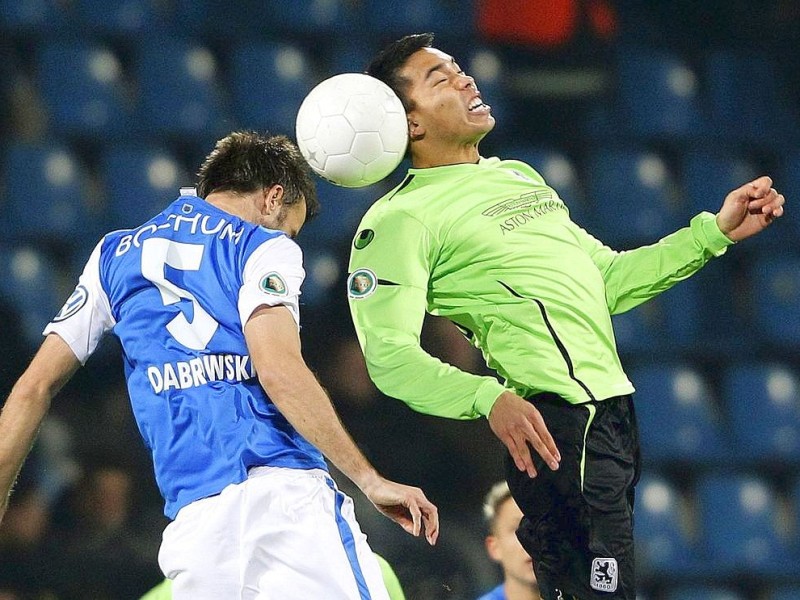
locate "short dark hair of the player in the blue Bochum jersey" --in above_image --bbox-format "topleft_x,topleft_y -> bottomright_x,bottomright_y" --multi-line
197,131 -> 319,221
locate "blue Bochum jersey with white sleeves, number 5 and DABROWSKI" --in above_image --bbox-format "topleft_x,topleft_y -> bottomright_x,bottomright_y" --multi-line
45,196 -> 327,518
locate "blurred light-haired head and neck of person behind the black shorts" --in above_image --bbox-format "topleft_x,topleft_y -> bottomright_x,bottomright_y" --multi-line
483,481 -> 539,600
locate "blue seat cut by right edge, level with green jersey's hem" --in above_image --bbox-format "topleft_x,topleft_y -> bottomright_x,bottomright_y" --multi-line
722,363 -> 800,467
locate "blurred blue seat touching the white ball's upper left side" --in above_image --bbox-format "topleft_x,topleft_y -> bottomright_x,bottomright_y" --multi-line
231,43 -> 316,139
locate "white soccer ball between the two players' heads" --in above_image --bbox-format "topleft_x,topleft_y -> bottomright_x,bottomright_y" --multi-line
296,73 -> 408,188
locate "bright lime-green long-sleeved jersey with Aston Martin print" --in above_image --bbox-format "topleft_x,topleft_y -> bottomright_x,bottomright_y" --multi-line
348,158 -> 732,419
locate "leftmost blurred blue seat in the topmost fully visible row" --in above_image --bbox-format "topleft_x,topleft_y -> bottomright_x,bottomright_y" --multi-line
36,41 -> 132,138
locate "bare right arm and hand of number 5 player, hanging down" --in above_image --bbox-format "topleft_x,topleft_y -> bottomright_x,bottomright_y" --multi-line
244,306 -> 439,545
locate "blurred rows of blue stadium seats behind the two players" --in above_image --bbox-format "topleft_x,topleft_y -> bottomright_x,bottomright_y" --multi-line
0,0 -> 800,600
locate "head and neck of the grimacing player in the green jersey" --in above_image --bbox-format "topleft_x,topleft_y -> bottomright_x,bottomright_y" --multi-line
367,33 -> 494,167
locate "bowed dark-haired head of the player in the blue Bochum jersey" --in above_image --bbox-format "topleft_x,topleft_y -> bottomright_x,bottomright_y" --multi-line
197,131 -> 319,235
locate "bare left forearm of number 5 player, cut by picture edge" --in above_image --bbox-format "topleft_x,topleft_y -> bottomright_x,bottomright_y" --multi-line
0,334 -> 80,521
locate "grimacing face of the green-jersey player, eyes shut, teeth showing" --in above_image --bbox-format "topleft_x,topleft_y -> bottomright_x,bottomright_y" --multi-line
400,48 -> 494,144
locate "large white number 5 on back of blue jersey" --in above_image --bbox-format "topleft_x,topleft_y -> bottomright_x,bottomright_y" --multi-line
142,238 -> 219,350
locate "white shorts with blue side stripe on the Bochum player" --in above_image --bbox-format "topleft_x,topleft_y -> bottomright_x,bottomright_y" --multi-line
158,467 -> 389,600
